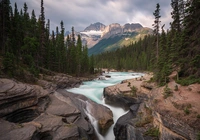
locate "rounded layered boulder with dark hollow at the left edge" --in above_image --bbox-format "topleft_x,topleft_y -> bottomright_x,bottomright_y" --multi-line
0,79 -> 49,123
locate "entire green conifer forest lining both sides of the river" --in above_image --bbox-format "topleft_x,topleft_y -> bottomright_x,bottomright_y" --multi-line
0,0 -> 200,85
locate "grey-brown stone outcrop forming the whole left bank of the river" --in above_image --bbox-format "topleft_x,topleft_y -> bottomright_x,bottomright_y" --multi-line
0,75 -> 113,140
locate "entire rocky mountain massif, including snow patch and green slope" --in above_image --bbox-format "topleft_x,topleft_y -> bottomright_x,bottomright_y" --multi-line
65,22 -> 152,55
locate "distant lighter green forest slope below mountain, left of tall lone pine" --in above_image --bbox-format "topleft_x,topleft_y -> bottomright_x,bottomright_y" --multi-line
95,36 -> 155,70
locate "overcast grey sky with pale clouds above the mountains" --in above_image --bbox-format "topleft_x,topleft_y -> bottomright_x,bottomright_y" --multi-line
10,0 -> 171,31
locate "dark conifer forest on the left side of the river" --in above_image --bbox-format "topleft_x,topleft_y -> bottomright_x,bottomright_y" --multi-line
0,0 -> 93,80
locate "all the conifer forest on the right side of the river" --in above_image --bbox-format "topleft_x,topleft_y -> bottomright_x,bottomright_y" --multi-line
95,0 -> 200,85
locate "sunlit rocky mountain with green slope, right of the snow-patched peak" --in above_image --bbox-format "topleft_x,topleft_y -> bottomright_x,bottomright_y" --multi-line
88,23 -> 152,55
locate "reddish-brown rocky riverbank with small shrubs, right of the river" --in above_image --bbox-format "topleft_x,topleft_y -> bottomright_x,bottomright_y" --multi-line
104,73 -> 200,140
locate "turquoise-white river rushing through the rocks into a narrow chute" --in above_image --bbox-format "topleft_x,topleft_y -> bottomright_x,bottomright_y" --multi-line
67,72 -> 143,140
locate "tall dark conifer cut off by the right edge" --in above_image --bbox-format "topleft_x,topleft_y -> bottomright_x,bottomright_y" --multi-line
180,0 -> 200,79
